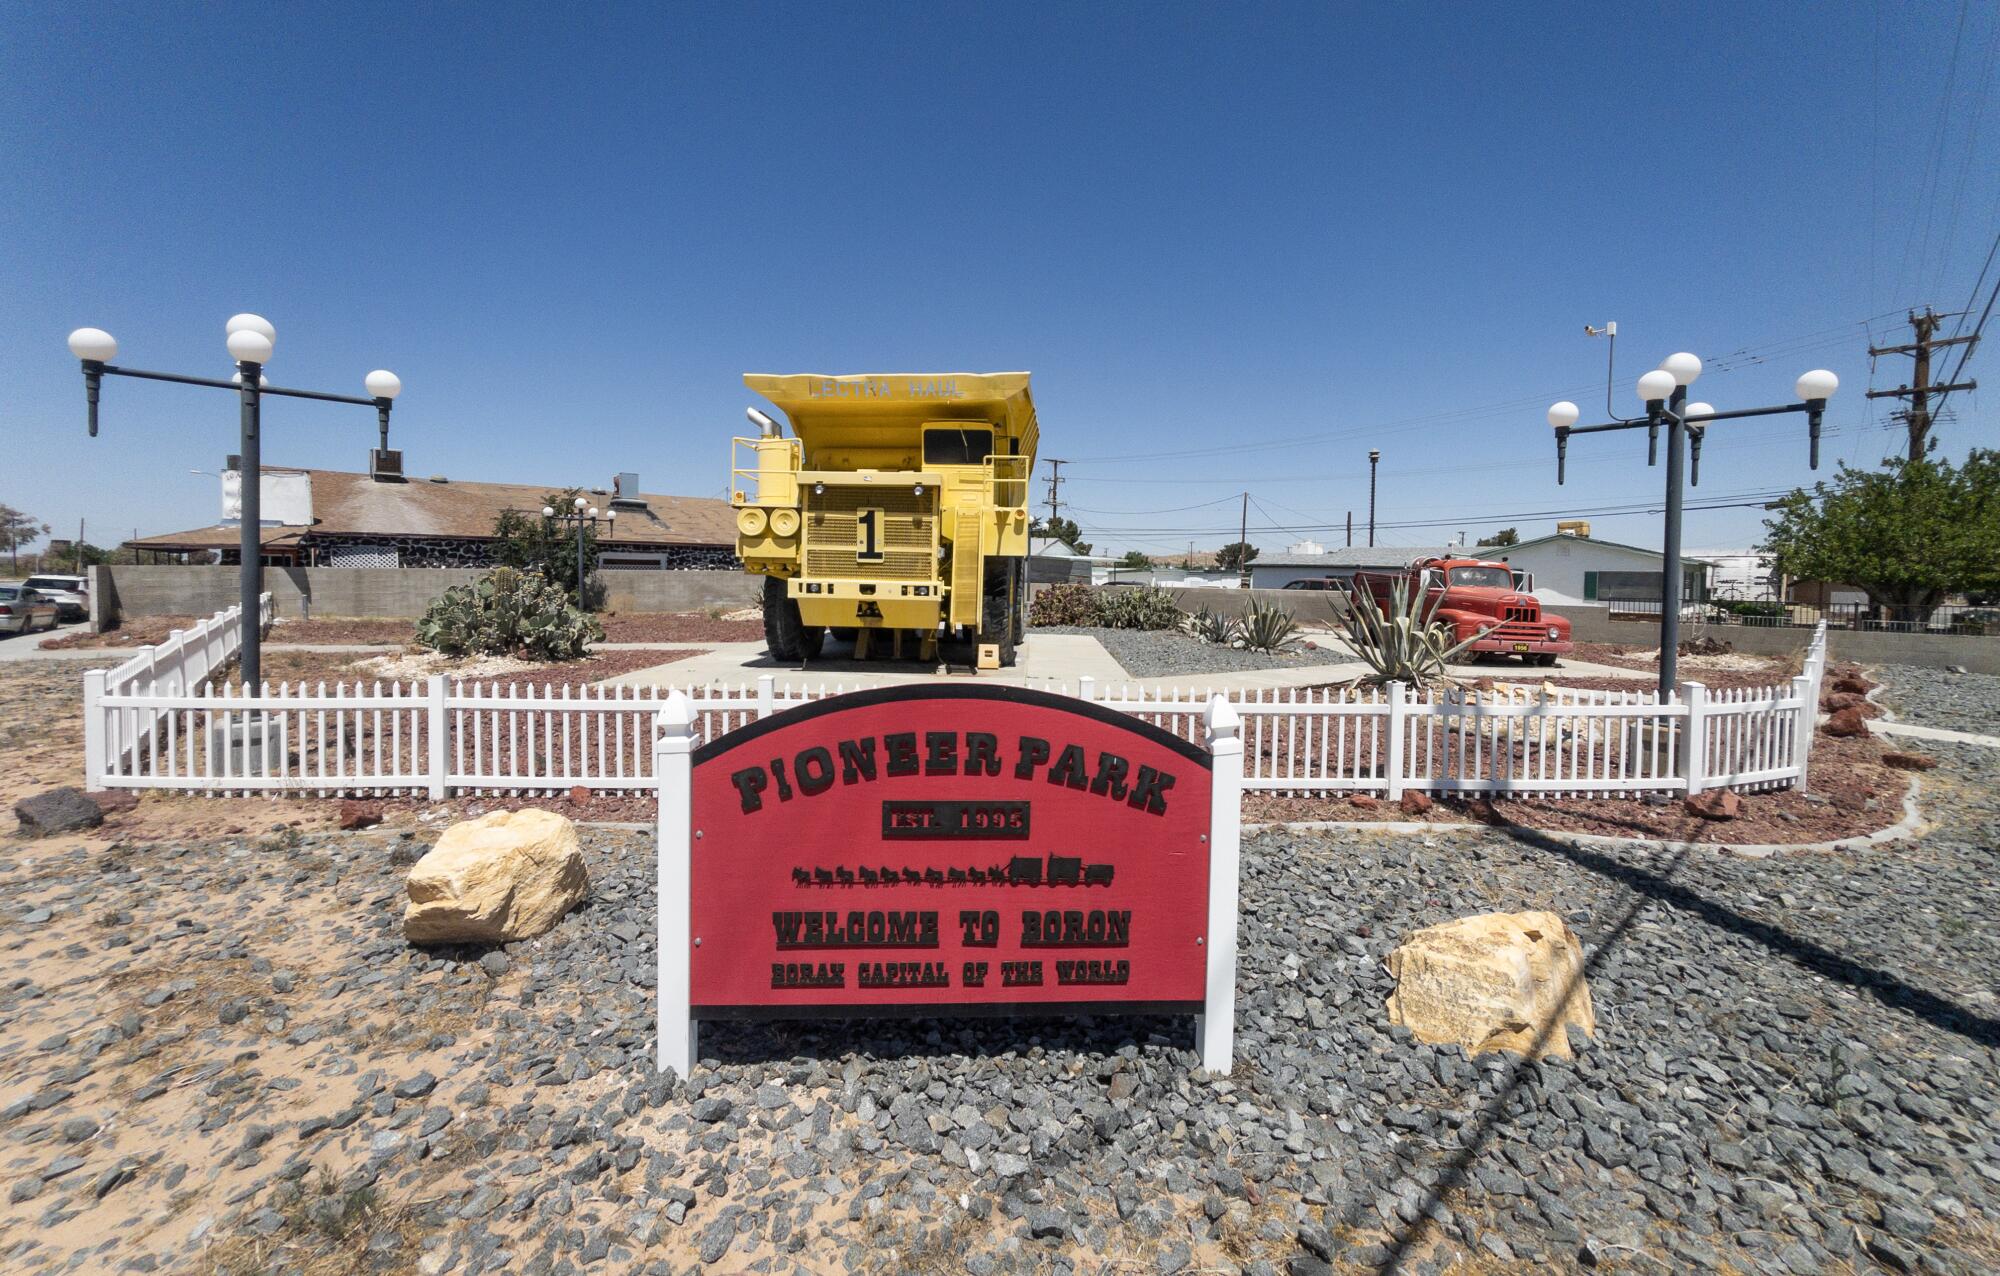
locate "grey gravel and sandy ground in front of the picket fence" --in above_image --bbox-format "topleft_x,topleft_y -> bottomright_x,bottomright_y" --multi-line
0,746 -> 2000,1276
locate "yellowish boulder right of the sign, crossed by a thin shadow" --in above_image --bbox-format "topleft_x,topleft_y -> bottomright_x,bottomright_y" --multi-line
1388,912 -> 1598,1058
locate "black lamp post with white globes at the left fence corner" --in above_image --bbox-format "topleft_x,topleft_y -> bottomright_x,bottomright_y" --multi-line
70,314 -> 402,688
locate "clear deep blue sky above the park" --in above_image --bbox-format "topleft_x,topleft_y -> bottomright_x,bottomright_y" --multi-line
0,2 -> 2000,550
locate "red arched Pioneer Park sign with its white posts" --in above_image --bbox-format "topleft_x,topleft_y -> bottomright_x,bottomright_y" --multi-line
654,684 -> 1242,1076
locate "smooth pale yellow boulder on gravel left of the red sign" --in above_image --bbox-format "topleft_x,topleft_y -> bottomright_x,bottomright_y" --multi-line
402,810 -> 590,944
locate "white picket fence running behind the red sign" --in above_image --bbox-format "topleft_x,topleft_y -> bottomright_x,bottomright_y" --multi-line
84,608 -> 1826,800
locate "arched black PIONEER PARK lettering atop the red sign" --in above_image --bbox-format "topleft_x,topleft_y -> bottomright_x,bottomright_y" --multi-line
730,732 -> 1174,816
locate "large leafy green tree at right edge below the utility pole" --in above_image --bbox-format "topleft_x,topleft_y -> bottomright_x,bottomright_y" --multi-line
1760,448 -> 2000,610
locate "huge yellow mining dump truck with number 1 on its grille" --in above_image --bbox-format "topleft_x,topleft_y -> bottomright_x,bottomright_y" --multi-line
730,372 -> 1040,664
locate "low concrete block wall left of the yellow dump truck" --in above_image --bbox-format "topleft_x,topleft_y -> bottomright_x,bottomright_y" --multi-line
92,566 -> 762,628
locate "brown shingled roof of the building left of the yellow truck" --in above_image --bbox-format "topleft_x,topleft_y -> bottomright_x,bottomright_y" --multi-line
126,466 -> 736,550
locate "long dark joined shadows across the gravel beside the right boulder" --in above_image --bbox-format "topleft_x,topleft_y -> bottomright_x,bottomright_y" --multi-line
1378,826 -> 2000,1272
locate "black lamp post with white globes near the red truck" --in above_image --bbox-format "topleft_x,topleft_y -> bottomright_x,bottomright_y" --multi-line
1548,352 -> 1840,696
